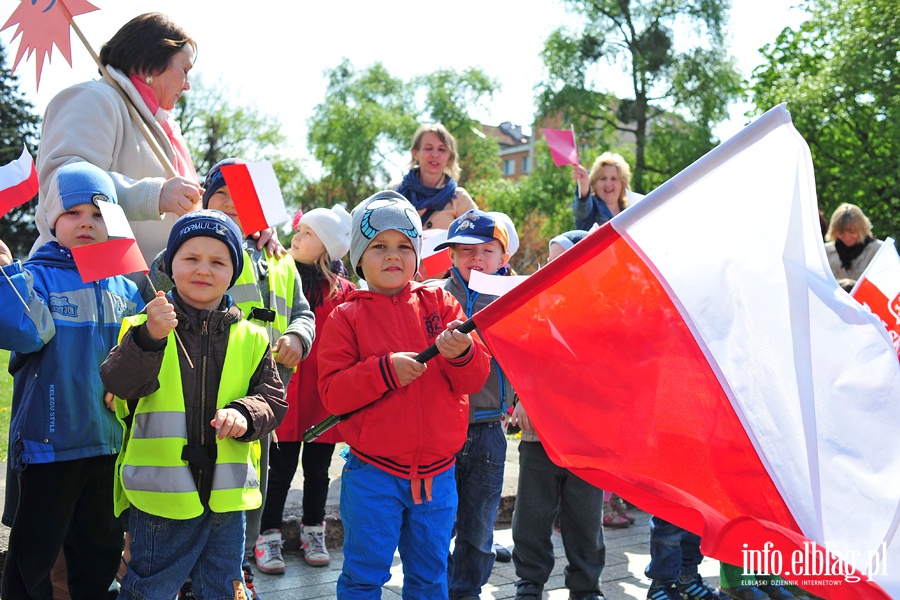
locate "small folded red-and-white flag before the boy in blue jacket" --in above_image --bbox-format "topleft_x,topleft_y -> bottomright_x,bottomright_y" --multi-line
72,201 -> 150,283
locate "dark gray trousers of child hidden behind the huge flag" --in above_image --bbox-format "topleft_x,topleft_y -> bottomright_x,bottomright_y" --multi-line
513,442 -> 606,594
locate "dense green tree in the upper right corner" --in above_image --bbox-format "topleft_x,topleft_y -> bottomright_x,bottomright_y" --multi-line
753,0 -> 900,239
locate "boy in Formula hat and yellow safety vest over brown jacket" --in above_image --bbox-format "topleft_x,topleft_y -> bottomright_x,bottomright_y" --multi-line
101,210 -> 287,598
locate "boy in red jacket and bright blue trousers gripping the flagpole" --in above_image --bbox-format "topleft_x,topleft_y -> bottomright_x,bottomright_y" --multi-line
318,191 -> 490,599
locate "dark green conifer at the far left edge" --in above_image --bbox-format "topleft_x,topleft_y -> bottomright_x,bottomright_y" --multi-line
0,45 -> 40,259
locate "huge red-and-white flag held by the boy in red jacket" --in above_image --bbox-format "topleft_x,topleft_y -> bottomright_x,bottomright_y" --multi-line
474,105 -> 900,600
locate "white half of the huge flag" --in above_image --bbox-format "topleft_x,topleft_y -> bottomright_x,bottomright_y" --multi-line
613,106 -> 900,594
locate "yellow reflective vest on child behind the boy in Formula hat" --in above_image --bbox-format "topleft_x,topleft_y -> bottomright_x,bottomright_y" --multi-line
228,250 -> 297,345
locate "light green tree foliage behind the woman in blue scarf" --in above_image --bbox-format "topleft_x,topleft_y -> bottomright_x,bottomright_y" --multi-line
308,60 -> 499,207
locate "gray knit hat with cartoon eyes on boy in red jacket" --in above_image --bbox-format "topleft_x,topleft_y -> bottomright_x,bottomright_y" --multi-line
350,190 -> 422,277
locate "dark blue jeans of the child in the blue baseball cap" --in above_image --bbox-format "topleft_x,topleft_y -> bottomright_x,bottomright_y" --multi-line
447,421 -> 506,598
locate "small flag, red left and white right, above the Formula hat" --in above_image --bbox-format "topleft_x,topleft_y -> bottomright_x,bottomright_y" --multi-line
222,162 -> 290,233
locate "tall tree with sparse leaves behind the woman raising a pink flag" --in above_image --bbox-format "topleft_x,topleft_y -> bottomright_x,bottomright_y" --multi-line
539,0 -> 742,192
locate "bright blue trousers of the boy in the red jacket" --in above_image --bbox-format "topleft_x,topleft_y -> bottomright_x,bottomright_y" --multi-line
337,453 -> 457,600
